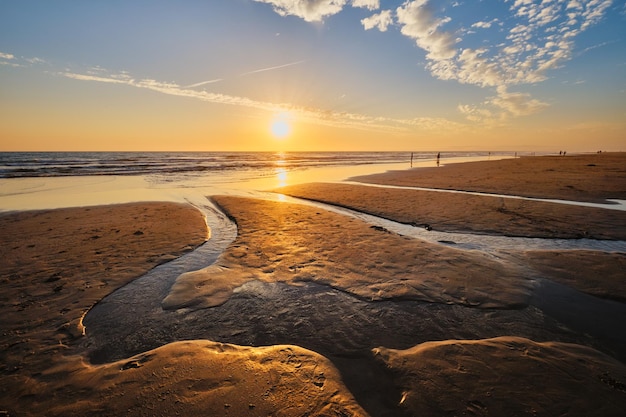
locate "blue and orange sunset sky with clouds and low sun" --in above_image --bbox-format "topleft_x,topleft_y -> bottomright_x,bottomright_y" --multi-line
0,0 -> 626,152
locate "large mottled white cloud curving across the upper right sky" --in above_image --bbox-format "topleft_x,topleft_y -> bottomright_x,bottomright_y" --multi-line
397,0 -> 611,87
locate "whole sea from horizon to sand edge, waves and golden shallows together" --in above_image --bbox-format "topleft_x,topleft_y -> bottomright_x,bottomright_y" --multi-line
0,152 -> 512,211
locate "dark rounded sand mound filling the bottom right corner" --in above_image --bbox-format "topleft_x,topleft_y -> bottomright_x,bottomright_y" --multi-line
374,337 -> 626,416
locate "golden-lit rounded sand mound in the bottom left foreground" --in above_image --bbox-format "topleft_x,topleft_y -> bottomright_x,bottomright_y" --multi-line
7,341 -> 367,417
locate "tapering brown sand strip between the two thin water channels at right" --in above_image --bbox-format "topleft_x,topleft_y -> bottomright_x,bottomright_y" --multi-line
276,181 -> 626,240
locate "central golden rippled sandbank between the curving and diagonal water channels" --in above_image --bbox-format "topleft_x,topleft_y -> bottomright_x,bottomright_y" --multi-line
163,196 -> 531,309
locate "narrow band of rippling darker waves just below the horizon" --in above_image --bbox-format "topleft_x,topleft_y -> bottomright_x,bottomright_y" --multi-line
0,152 -> 502,178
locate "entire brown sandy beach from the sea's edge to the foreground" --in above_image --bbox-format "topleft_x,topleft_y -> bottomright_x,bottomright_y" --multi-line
0,153 -> 626,417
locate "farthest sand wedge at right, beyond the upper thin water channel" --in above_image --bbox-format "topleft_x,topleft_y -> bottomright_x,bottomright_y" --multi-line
354,152 -> 626,203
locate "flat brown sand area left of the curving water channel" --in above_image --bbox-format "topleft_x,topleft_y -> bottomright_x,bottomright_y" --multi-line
0,203 -> 208,374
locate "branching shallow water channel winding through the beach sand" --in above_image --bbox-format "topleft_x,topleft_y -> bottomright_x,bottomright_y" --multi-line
82,194 -> 626,417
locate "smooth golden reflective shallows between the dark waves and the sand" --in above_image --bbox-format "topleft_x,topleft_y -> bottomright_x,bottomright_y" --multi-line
0,155 -> 500,213
